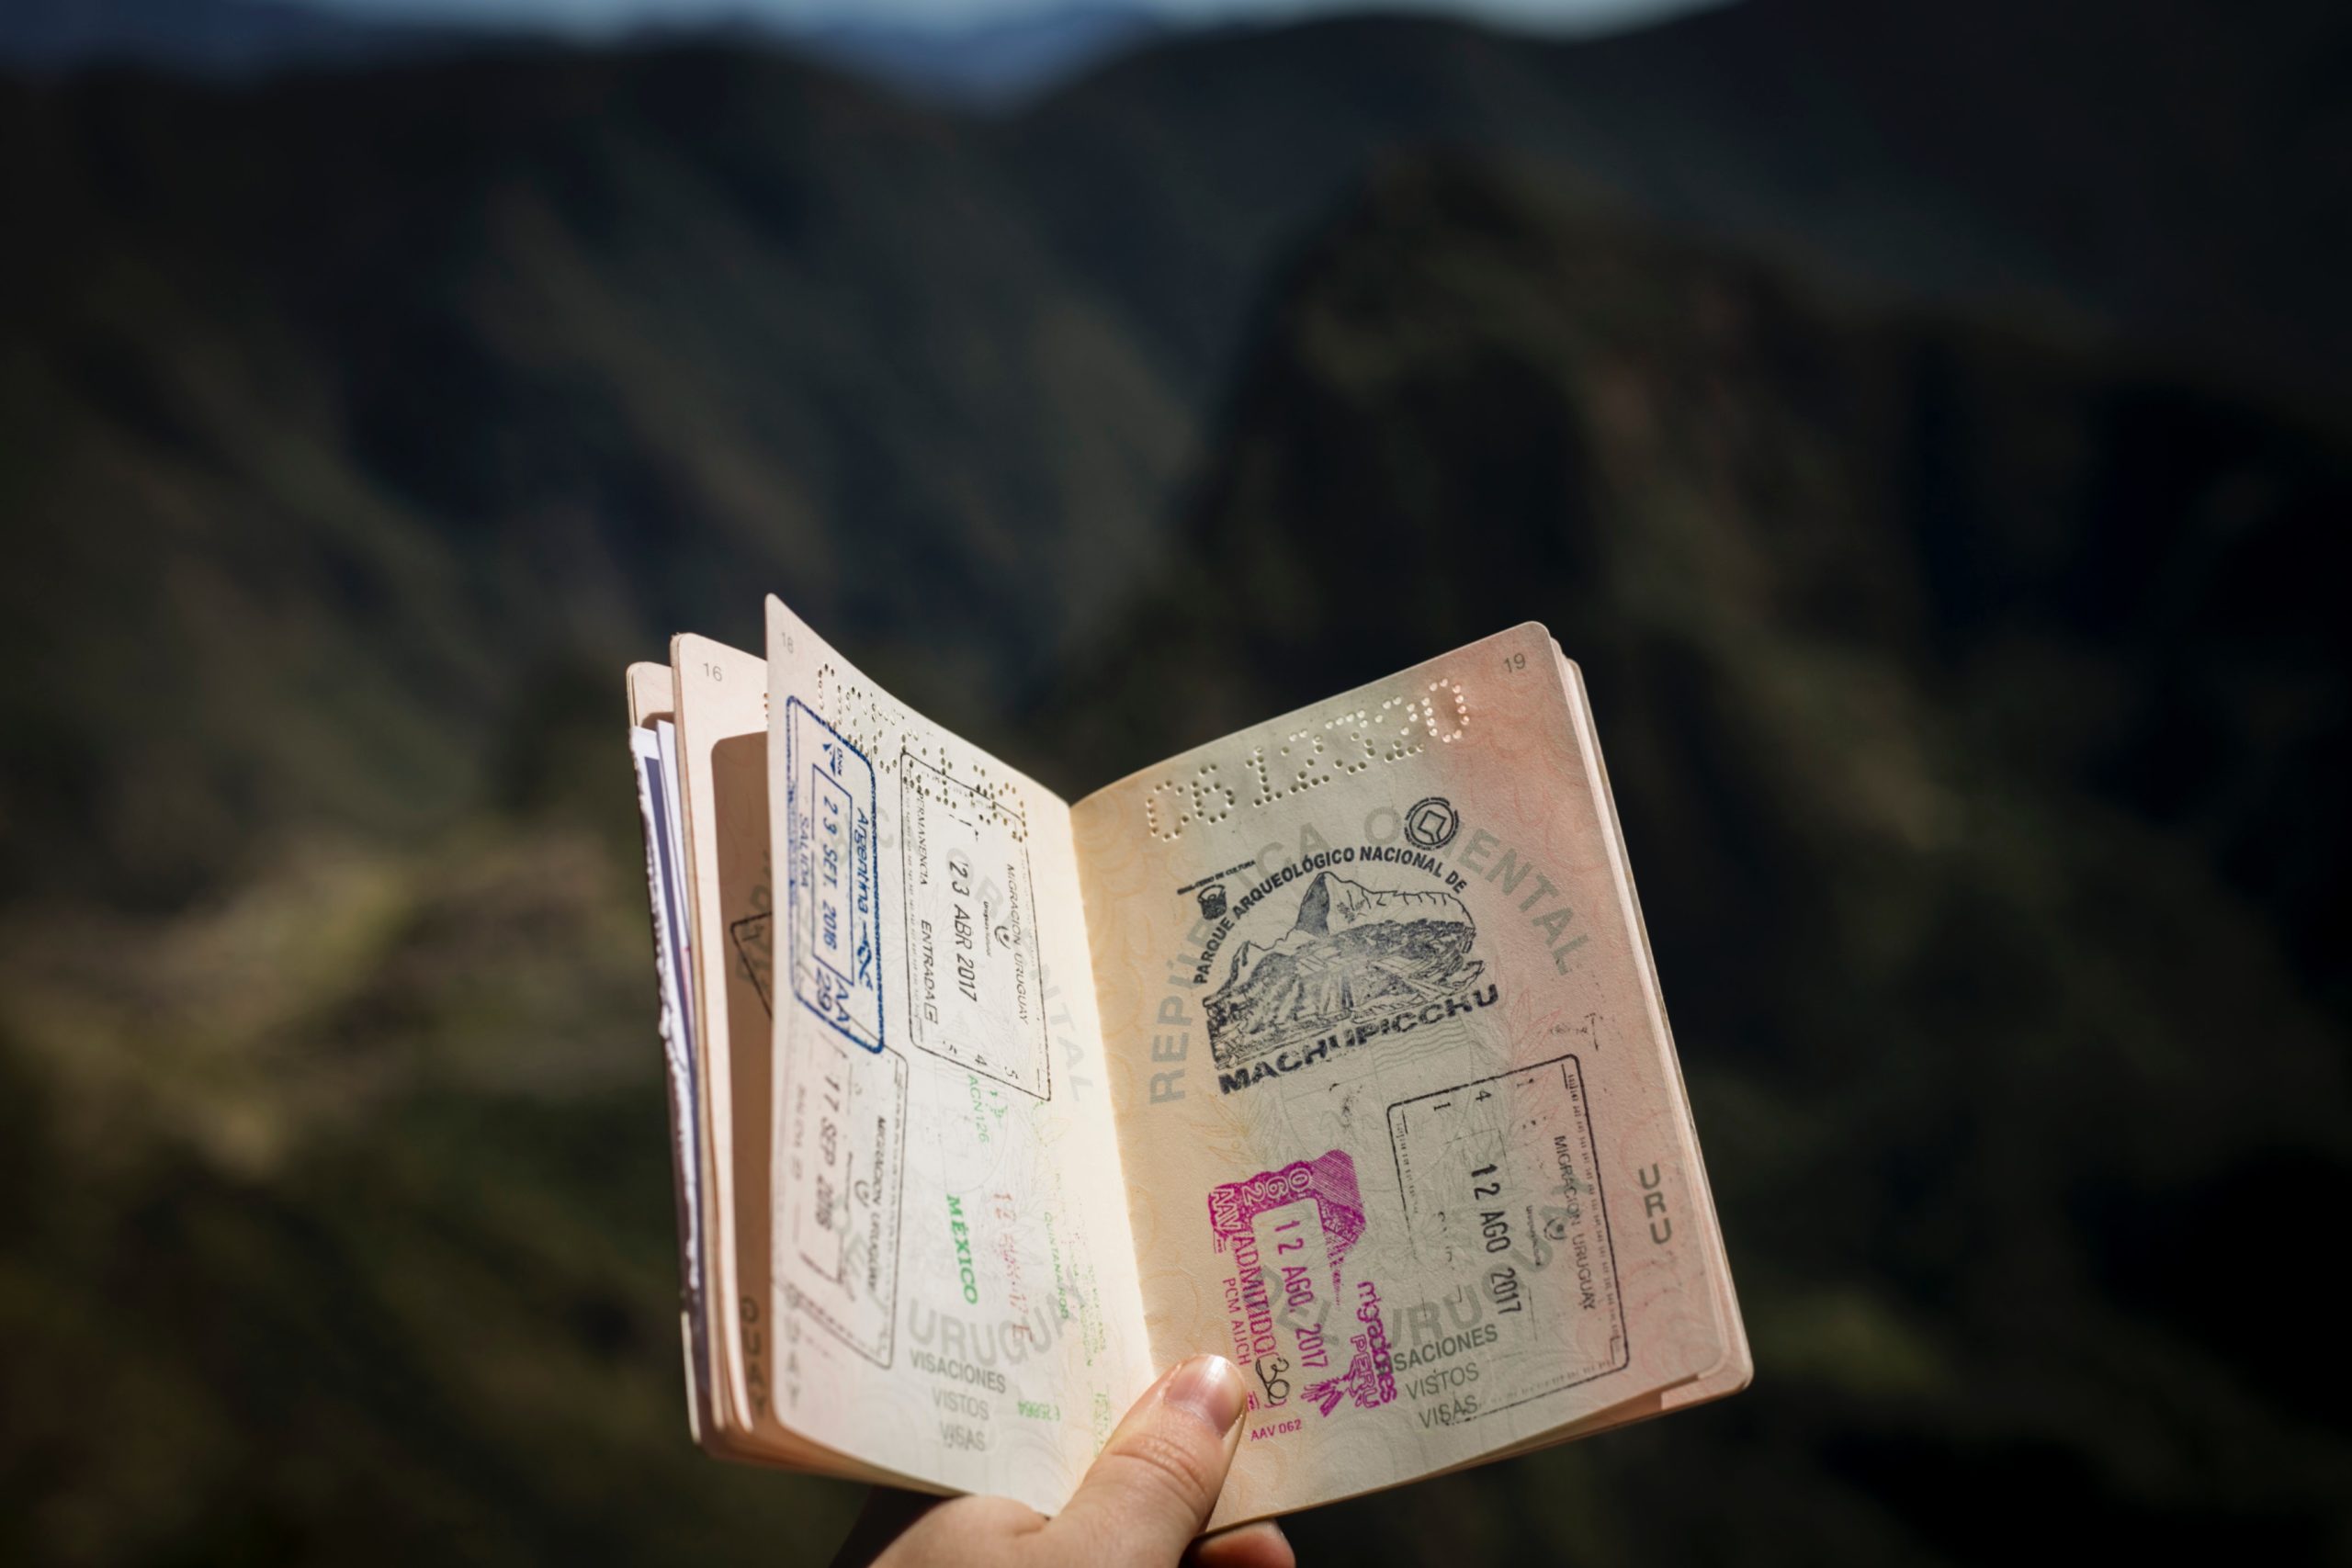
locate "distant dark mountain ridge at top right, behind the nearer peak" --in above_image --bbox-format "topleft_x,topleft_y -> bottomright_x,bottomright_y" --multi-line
1023,0 -> 2352,411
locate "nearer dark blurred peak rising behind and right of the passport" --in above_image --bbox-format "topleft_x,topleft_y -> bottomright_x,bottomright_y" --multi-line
1042,160 -> 2352,1563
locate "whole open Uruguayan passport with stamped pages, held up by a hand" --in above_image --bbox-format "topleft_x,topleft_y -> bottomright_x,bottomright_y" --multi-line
628,597 -> 1750,1528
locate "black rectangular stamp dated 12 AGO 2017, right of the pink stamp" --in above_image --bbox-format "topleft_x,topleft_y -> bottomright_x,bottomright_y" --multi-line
1387,1055 -> 1633,1420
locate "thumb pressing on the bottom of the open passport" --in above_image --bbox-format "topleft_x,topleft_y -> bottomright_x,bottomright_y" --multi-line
1045,1357 -> 1249,1563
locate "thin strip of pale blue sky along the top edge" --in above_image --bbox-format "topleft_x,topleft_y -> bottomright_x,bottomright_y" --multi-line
299,0 -> 1710,35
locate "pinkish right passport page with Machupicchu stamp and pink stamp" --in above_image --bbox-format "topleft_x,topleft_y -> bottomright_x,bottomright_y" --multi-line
1072,626 -> 1747,1526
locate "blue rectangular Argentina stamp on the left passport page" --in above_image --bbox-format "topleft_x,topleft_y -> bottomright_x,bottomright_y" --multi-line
786,696 -> 882,1051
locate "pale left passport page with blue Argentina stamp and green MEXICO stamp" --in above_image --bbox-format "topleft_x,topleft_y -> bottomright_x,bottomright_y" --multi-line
767,597 -> 1155,1512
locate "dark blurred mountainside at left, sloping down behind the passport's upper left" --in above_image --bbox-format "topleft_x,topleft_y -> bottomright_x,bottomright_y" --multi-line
0,51 -> 1190,896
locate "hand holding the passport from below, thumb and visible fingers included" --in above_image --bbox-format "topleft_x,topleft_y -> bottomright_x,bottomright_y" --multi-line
832,1357 -> 1298,1568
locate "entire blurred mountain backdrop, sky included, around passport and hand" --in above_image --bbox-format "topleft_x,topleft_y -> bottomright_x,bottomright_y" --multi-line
0,0 -> 2352,1563
